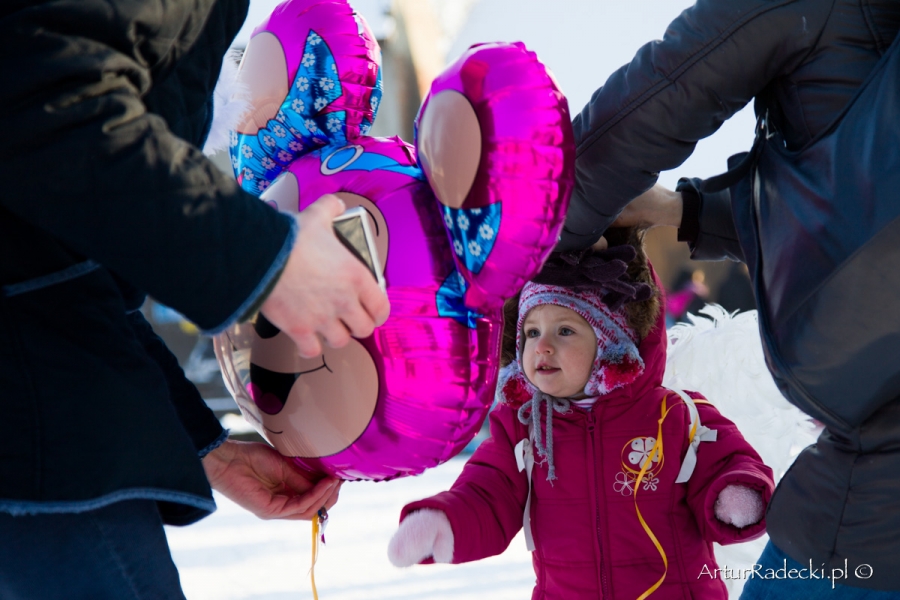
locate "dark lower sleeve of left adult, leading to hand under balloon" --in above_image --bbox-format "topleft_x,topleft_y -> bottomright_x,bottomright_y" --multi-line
128,310 -> 225,457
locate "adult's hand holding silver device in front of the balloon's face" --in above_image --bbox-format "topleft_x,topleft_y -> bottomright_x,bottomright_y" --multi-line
261,194 -> 390,358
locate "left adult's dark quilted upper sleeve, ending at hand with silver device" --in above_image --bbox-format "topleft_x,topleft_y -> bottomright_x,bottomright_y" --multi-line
0,0 -> 296,330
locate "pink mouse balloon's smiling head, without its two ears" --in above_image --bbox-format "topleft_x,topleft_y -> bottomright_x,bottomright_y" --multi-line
217,137 -> 502,480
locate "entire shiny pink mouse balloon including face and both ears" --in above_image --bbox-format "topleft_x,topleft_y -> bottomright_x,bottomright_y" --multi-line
216,0 -> 574,480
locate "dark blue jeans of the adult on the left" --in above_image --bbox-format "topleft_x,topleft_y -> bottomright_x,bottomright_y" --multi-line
0,500 -> 184,600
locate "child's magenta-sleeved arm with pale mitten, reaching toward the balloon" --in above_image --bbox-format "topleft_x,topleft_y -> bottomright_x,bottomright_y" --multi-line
388,405 -> 528,566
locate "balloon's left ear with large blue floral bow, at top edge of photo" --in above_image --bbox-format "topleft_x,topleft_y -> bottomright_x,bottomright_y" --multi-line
231,0 -> 381,195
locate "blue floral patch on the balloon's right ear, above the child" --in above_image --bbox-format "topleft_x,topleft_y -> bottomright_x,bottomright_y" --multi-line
443,202 -> 502,274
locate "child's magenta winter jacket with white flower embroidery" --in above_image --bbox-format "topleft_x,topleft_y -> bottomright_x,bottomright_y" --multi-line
401,308 -> 774,600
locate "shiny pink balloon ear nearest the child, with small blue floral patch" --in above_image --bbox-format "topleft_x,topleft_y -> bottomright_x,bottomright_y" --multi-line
416,43 -> 575,309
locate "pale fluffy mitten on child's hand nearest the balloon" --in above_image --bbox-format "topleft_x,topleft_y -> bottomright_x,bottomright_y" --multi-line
388,508 -> 453,567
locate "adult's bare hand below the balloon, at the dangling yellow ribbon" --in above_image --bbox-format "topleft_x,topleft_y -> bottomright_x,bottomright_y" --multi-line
203,440 -> 343,521
